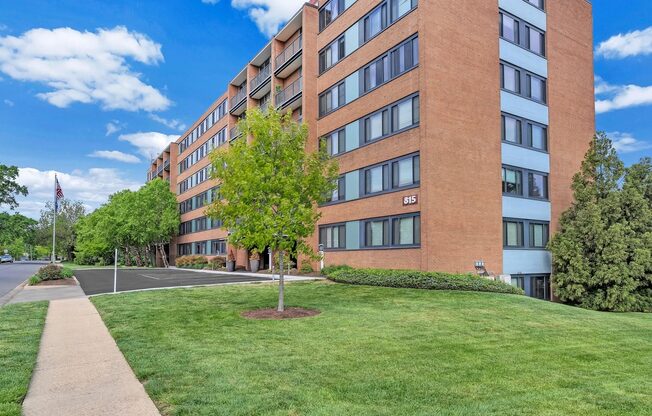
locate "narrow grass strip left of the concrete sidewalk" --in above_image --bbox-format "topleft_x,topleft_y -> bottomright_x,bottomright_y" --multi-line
0,302 -> 48,416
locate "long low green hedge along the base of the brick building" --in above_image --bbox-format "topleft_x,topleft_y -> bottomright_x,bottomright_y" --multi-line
327,267 -> 523,295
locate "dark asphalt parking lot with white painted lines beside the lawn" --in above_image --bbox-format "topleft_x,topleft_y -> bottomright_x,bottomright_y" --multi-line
75,269 -> 271,295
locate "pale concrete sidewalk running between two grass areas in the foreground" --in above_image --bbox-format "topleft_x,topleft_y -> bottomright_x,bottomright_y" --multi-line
23,298 -> 159,416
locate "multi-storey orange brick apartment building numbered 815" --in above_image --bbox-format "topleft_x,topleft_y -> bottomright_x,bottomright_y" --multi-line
148,0 -> 595,298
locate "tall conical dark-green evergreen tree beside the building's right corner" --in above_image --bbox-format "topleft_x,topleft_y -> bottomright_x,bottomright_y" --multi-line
550,133 -> 646,311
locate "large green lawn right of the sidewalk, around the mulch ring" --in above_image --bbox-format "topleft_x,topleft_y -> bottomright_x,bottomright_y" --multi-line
93,282 -> 652,416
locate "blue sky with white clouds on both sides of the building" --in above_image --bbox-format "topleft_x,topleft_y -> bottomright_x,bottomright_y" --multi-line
0,0 -> 652,216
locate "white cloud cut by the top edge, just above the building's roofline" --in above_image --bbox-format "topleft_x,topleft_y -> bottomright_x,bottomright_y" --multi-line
228,0 -> 306,37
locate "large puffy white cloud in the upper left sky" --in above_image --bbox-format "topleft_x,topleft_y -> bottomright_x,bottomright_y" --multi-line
0,26 -> 171,111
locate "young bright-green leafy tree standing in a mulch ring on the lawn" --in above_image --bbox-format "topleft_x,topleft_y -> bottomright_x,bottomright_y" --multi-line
207,108 -> 338,312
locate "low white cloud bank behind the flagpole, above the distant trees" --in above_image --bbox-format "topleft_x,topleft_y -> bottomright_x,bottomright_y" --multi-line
12,167 -> 142,218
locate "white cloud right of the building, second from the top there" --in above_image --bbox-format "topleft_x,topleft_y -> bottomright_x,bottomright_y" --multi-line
595,77 -> 652,114
